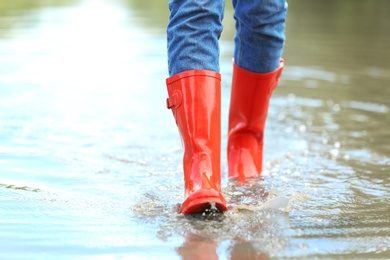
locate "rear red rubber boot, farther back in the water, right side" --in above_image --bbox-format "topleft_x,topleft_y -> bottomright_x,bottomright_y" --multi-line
227,59 -> 284,182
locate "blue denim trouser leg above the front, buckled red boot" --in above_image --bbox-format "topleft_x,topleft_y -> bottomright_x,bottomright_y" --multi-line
167,0 -> 225,76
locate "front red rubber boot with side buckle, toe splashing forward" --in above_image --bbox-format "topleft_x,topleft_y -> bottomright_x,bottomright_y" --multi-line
166,70 -> 227,214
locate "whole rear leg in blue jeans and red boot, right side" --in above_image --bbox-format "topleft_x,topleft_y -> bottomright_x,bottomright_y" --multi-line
227,0 -> 287,181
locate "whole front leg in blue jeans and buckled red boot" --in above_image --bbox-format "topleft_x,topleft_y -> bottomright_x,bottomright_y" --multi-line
166,0 -> 227,214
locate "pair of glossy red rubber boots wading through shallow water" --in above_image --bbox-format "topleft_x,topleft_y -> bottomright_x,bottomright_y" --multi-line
166,60 -> 284,214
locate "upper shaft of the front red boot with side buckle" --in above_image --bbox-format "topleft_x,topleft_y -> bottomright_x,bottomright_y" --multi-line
166,70 -> 221,161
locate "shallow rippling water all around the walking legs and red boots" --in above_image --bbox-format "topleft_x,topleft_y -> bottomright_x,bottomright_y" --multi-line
0,0 -> 390,259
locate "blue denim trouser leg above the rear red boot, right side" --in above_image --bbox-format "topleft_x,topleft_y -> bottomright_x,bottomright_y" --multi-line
233,0 -> 287,73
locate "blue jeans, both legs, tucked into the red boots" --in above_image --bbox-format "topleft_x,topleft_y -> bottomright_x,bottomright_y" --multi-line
167,0 -> 287,76
